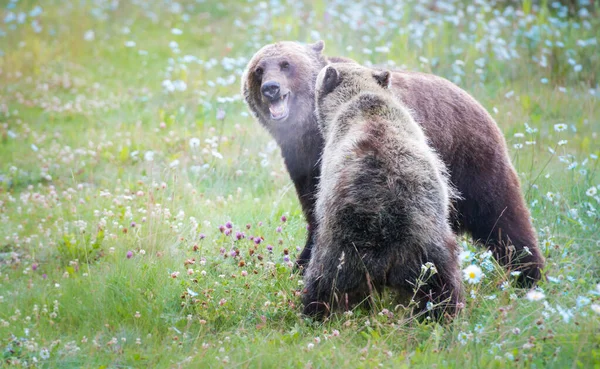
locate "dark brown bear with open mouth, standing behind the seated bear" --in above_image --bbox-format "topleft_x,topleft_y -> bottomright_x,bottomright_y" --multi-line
242,41 -> 544,285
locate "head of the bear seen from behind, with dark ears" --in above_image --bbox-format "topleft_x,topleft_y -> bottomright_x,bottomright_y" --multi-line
315,63 -> 391,137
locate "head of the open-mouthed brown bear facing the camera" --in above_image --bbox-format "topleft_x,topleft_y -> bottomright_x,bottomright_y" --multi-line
242,41 -> 327,133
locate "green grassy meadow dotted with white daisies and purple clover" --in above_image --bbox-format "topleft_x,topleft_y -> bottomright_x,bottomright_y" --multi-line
0,0 -> 600,368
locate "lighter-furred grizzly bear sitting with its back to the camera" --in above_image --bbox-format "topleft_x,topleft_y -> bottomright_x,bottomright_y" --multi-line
303,64 -> 462,317
